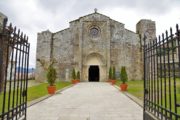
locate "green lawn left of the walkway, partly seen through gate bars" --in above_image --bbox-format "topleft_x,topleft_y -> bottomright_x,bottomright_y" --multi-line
0,82 -> 71,114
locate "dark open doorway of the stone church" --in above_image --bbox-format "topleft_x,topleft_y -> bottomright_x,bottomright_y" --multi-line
89,65 -> 99,82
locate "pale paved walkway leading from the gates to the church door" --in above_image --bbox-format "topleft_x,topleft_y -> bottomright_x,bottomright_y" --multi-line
27,82 -> 143,120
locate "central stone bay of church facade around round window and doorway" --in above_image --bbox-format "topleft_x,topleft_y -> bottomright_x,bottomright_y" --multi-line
80,13 -> 110,81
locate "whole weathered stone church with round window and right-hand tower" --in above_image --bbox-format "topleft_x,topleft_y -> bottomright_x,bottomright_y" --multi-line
36,10 -> 156,82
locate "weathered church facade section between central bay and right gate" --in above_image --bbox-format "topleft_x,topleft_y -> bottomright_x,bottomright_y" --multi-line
111,21 -> 143,80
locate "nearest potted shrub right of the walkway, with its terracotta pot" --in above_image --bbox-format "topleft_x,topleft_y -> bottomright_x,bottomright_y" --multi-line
120,66 -> 128,91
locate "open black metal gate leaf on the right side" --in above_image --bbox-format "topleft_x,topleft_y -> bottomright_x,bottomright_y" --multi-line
144,25 -> 180,120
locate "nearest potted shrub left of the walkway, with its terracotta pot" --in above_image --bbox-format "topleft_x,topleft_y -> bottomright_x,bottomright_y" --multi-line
47,64 -> 57,94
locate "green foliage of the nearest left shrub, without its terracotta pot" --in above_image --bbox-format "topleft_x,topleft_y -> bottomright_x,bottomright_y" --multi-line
47,65 -> 57,86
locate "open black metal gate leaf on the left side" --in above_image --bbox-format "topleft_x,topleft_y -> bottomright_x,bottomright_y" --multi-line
0,19 -> 30,120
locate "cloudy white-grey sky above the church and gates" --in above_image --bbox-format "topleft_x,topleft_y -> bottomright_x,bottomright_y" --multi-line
0,0 -> 180,67
